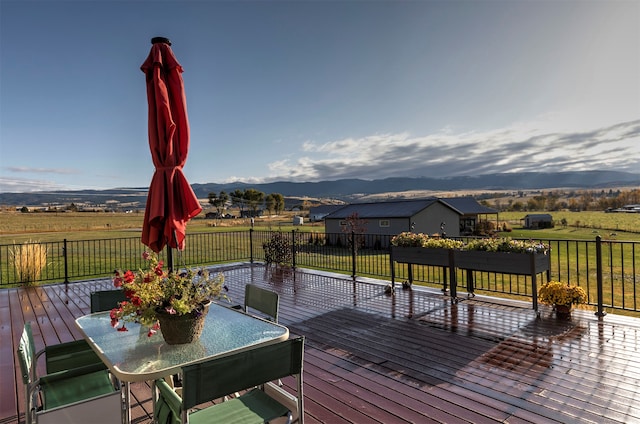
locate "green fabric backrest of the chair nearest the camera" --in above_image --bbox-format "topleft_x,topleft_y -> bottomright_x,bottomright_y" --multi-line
182,337 -> 304,411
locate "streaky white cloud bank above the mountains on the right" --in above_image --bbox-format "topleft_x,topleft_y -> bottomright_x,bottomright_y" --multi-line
268,120 -> 640,181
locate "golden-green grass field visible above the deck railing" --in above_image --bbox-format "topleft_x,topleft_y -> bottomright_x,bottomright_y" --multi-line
0,212 -> 640,244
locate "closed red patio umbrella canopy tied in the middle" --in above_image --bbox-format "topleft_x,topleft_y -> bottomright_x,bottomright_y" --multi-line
141,37 -> 202,253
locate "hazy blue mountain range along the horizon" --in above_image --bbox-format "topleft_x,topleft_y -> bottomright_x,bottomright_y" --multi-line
0,171 -> 640,207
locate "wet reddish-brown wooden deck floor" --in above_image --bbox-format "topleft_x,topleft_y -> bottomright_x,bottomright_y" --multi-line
0,264 -> 640,424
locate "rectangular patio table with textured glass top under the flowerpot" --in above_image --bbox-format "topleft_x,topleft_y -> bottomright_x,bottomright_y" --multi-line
76,303 -> 289,423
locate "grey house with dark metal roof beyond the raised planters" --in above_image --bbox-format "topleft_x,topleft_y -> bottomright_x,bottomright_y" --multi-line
324,197 -> 497,247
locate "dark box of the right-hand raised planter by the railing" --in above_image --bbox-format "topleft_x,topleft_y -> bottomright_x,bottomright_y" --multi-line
454,250 -> 551,275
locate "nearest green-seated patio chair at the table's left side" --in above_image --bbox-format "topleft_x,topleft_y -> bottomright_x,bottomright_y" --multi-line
17,322 -> 122,424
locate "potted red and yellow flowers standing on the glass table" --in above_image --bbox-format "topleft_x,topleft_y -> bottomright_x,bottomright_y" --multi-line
111,252 -> 228,344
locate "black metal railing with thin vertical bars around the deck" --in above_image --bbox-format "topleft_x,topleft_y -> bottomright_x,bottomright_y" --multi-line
0,230 -> 640,312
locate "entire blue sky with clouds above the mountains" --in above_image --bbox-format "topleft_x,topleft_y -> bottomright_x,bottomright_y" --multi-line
0,0 -> 640,192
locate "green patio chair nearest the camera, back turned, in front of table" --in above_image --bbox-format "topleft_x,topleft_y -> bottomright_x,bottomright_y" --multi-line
155,337 -> 304,424
